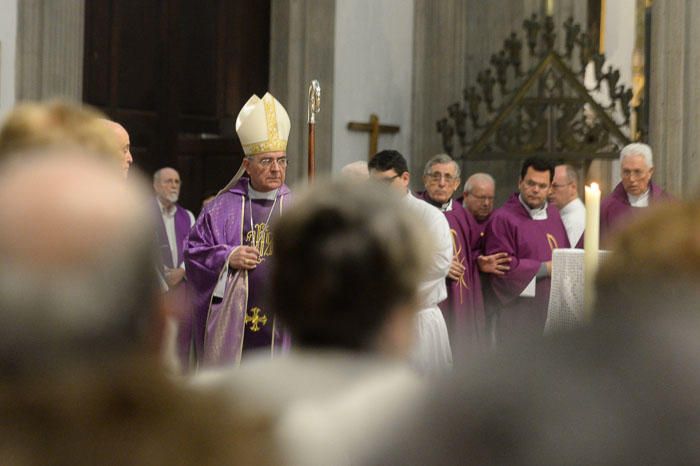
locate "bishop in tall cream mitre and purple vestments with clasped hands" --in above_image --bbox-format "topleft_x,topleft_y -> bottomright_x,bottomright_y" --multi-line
185,93 -> 290,367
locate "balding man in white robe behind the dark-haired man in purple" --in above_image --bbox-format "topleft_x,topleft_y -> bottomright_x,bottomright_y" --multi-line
549,164 -> 586,247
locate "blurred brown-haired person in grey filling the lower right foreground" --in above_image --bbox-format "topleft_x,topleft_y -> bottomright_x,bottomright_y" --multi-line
377,201 -> 700,466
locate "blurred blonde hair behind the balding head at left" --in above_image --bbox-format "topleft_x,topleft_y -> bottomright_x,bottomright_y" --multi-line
0,100 -> 123,162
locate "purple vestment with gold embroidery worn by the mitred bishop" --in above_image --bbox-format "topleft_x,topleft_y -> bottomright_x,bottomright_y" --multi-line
185,178 -> 290,366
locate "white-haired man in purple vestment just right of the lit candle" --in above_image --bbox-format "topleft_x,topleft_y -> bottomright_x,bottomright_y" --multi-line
600,143 -> 673,241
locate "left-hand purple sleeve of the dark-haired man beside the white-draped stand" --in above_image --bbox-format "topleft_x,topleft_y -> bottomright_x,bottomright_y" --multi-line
484,215 -> 542,304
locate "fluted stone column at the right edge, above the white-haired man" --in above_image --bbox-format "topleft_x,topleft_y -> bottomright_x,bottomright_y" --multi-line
648,0 -> 700,196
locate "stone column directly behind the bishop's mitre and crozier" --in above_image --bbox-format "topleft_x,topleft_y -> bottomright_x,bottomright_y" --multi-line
270,0 -> 335,183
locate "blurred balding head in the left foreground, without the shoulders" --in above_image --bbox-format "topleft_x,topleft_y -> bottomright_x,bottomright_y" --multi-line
0,151 -> 158,368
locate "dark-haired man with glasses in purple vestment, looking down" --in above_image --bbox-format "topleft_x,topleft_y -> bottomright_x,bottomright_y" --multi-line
484,157 -> 569,343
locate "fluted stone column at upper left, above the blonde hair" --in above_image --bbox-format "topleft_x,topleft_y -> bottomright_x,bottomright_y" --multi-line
16,0 -> 85,101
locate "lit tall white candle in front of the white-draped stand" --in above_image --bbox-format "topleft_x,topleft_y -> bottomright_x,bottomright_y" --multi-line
583,183 -> 600,321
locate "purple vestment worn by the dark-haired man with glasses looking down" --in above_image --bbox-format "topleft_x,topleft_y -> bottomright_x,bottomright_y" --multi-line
484,193 -> 569,342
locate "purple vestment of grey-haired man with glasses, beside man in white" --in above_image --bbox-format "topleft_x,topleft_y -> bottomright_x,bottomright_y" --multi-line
417,192 -> 488,354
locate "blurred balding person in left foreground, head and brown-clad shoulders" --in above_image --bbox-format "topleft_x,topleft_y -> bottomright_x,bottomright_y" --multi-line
0,149 -> 269,466
